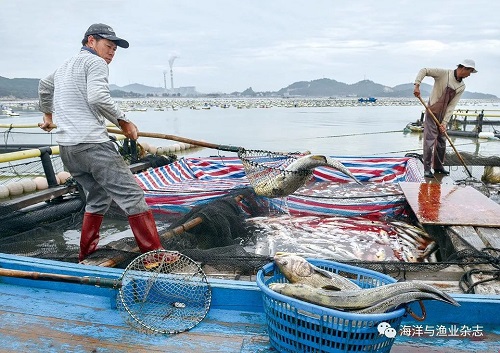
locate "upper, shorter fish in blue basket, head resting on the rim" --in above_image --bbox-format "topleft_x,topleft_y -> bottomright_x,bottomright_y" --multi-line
274,253 -> 360,290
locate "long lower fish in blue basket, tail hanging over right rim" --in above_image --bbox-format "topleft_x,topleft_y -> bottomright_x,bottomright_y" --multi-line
269,281 -> 459,313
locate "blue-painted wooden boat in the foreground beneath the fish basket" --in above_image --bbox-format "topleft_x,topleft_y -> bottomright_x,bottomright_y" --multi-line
0,255 -> 500,353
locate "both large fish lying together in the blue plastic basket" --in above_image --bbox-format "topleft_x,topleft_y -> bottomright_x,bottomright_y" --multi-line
269,253 -> 459,314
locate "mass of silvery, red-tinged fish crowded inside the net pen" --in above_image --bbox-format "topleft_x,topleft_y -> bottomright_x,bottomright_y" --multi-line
246,215 -> 438,262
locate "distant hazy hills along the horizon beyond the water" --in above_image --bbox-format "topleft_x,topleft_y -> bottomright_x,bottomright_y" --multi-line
0,76 -> 498,99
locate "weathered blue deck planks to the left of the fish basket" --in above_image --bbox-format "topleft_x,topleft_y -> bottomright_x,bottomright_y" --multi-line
0,283 -> 272,353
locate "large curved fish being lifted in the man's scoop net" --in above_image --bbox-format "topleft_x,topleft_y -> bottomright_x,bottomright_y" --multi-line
252,155 -> 361,197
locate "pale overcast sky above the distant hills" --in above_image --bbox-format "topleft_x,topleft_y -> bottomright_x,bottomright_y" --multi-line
0,0 -> 500,97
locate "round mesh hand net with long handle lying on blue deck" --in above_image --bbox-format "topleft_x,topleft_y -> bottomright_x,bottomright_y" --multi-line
0,250 -> 212,334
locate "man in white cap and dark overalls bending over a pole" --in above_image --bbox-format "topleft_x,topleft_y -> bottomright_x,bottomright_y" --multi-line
413,59 -> 477,178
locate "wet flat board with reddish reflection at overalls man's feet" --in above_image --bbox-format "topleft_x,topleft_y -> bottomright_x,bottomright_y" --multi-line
399,183 -> 500,227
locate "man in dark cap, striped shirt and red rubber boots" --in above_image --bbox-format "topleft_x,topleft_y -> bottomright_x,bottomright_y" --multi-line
38,23 -> 162,261
